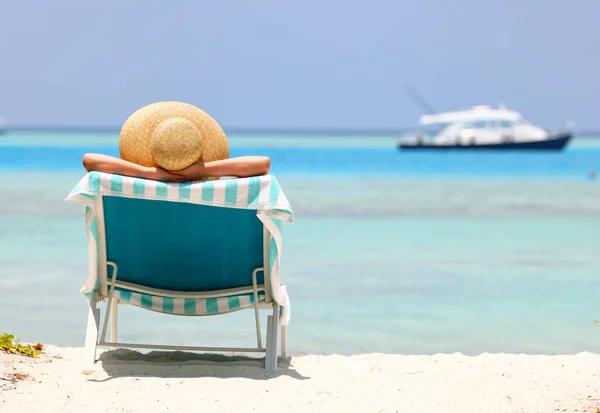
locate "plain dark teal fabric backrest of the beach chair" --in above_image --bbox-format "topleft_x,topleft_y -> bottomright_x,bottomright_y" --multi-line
103,196 -> 264,291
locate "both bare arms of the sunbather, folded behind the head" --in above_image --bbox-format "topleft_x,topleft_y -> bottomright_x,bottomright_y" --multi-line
83,153 -> 271,182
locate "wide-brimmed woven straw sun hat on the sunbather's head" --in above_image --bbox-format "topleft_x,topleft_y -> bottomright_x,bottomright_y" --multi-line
119,102 -> 229,171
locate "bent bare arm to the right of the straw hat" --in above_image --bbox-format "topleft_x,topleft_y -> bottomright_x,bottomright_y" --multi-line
175,156 -> 271,181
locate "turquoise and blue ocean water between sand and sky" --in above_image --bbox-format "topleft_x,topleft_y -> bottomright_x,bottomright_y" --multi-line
0,132 -> 600,354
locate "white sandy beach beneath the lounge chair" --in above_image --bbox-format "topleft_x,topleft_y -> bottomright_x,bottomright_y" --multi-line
0,347 -> 600,413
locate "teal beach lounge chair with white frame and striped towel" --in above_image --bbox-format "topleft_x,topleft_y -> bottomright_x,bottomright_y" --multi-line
67,172 -> 293,374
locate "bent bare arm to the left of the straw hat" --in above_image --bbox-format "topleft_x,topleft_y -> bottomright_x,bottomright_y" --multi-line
83,153 -> 185,182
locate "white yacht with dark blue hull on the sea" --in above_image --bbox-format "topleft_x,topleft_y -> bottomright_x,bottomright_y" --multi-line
398,106 -> 573,151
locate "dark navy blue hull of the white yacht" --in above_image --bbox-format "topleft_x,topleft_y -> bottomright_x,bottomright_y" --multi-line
398,133 -> 573,151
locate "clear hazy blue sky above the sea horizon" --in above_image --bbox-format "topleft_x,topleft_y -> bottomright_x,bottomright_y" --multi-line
0,0 -> 600,131
